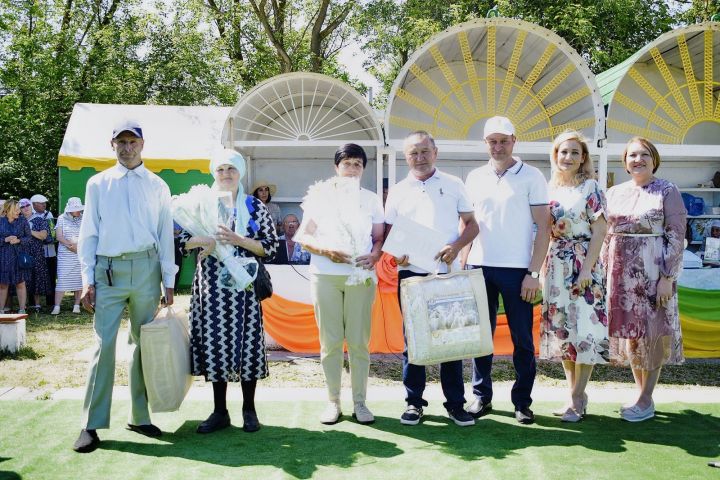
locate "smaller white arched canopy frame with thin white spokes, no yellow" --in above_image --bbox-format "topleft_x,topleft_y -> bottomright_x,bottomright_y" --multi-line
222,72 -> 385,202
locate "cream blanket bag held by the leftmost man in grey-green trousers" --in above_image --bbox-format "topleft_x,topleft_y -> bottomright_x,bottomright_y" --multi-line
140,307 -> 192,412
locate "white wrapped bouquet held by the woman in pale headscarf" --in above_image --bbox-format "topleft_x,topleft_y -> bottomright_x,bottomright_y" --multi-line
172,185 -> 257,291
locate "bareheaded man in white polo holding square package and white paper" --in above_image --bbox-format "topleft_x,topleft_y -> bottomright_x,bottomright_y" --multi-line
385,131 -> 478,426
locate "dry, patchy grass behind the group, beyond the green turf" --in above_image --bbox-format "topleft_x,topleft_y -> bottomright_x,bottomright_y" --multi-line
0,292 -> 720,398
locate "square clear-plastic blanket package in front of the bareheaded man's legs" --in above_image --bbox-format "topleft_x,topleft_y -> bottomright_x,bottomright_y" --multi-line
400,269 -> 493,365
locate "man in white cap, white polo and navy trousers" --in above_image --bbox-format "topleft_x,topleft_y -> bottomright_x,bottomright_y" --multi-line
465,117 -> 550,424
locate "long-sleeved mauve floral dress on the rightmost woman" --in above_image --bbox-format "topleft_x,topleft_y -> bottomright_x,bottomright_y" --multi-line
602,179 -> 687,370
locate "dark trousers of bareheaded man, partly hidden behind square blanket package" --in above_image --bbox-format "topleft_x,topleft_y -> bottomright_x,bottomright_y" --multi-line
398,270 -> 465,410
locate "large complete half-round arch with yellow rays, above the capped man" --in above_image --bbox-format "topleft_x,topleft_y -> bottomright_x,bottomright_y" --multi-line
385,18 -> 605,142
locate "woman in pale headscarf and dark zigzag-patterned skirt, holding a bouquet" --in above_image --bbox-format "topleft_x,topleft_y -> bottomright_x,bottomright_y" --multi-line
179,150 -> 278,433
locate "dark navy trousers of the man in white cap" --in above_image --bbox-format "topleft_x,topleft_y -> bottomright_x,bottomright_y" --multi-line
469,265 -> 537,409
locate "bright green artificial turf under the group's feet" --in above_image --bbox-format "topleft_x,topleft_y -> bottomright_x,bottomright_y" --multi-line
0,401 -> 720,480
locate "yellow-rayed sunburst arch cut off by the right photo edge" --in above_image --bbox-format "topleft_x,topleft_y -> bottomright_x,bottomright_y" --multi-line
599,22 -> 720,145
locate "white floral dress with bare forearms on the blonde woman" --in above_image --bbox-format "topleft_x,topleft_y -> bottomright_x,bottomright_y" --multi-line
540,180 -> 610,365
